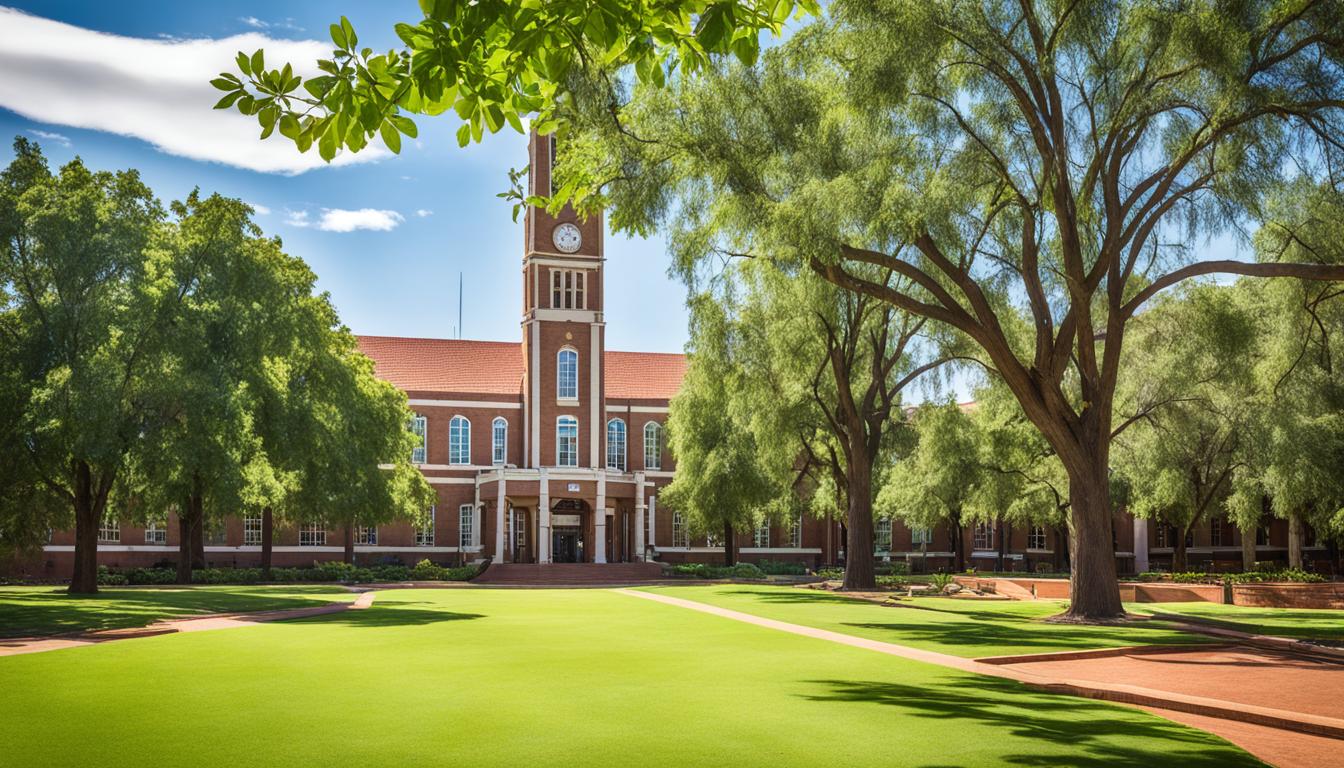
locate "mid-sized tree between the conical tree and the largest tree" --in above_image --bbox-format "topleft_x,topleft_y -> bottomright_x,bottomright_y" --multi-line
692,260 -> 950,589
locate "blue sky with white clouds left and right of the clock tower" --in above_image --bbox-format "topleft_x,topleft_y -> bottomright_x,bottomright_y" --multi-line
0,0 -> 687,352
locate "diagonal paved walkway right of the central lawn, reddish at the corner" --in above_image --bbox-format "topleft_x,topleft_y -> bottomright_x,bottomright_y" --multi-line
616,589 -> 1344,768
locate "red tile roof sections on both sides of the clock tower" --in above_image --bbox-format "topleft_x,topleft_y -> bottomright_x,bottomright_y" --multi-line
356,336 -> 685,399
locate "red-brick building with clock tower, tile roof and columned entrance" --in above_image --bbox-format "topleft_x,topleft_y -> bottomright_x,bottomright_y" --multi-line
22,136 -> 1322,578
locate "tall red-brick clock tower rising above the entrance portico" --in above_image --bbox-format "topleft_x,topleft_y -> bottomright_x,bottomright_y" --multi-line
521,132 -> 605,469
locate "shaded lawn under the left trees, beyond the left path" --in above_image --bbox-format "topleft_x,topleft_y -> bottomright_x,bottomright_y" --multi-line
0,585 -> 355,638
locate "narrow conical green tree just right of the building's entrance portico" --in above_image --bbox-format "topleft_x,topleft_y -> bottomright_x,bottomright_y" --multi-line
661,296 -> 793,565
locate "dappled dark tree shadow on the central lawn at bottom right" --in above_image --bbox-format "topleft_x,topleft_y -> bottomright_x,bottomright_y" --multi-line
804,677 -> 1262,768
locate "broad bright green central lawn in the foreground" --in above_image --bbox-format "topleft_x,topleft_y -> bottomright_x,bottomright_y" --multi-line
0,589 -> 1258,768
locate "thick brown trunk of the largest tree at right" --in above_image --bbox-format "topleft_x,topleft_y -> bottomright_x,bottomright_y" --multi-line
1066,460 -> 1125,621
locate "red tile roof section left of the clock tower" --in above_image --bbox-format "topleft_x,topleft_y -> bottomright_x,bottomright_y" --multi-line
356,336 -> 523,395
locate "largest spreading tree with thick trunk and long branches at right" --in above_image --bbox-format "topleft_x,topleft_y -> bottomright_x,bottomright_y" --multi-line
560,0 -> 1344,620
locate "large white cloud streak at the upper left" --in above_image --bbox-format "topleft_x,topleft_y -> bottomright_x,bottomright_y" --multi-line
0,7 -> 388,174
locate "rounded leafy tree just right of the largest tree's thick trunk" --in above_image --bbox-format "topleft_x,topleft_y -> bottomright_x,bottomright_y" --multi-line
1114,285 -> 1263,572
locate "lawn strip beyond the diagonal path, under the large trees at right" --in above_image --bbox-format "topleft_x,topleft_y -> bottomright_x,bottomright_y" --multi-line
648,584 -> 1208,658
